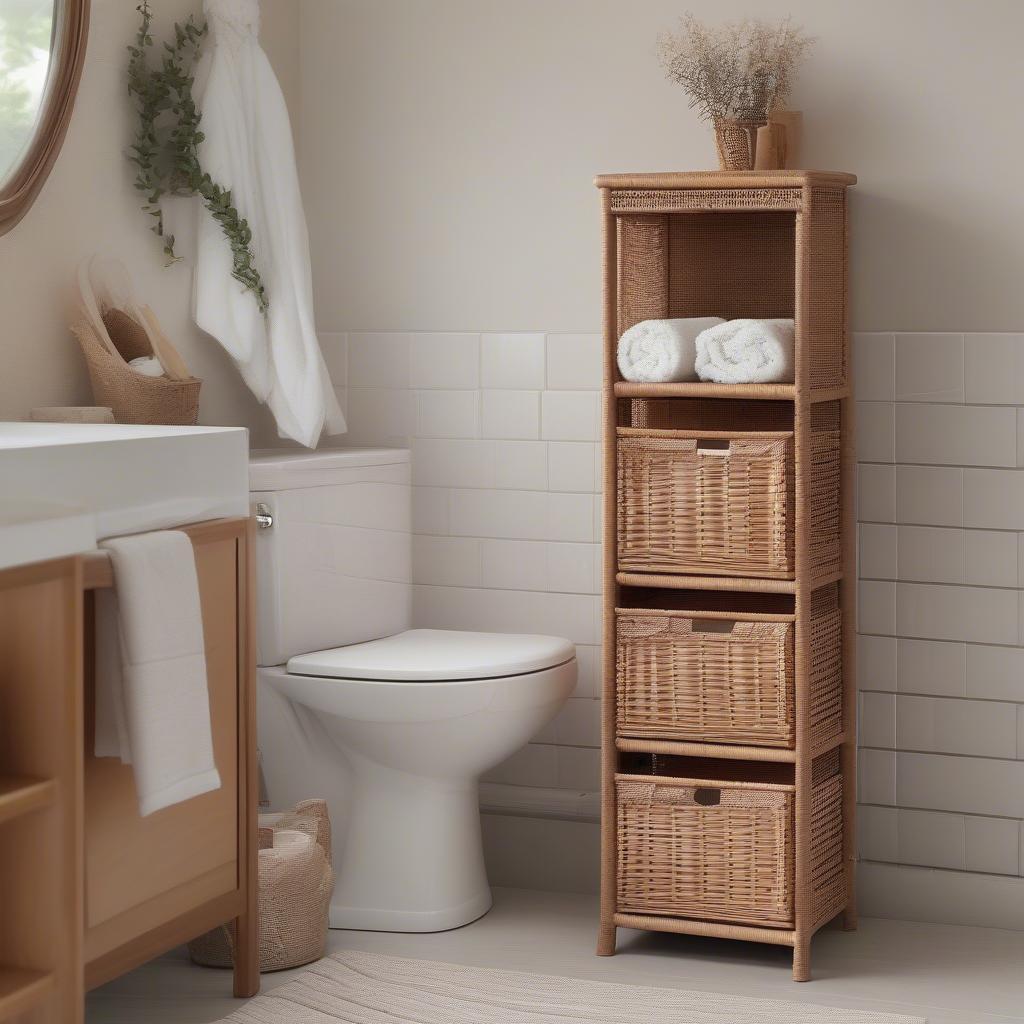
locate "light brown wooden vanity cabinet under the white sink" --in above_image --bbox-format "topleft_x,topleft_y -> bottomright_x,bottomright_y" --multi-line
0,519 -> 259,1024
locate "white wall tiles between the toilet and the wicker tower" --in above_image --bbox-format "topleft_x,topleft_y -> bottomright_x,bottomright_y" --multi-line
339,333 -> 601,793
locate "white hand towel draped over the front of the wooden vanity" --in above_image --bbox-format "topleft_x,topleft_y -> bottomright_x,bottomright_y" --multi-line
95,530 -> 220,817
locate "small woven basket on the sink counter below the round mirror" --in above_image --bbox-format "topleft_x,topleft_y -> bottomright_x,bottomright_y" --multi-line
72,309 -> 203,426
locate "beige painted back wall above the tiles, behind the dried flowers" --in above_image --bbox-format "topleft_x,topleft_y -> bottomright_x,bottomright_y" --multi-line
301,0 -> 1024,331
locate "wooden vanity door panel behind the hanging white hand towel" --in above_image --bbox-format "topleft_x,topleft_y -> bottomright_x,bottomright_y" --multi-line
85,520 -> 255,987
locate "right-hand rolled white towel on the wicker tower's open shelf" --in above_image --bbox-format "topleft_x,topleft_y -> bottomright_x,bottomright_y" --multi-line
696,319 -> 796,384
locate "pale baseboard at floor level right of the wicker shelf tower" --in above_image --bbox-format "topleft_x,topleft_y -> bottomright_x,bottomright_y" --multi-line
857,861 -> 1024,931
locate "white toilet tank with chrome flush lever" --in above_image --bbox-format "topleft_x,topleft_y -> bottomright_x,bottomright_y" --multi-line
249,449 -> 413,666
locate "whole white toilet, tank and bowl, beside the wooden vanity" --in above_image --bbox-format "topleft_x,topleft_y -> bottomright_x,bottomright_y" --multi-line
250,449 -> 577,932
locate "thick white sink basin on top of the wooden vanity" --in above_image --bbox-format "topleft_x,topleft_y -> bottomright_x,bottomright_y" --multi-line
0,423 -> 249,567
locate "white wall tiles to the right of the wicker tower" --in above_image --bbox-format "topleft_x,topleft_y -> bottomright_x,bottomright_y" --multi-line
853,334 -> 1024,892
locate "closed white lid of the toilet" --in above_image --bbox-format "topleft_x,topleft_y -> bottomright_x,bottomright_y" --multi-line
288,630 -> 575,682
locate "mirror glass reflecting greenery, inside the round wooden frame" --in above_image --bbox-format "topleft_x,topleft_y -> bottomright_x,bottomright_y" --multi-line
0,0 -> 59,185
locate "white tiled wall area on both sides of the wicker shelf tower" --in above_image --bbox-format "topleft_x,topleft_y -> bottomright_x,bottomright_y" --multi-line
325,325 -> 1024,909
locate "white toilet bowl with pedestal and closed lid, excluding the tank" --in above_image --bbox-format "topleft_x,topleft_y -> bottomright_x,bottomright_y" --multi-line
265,630 -> 577,932
